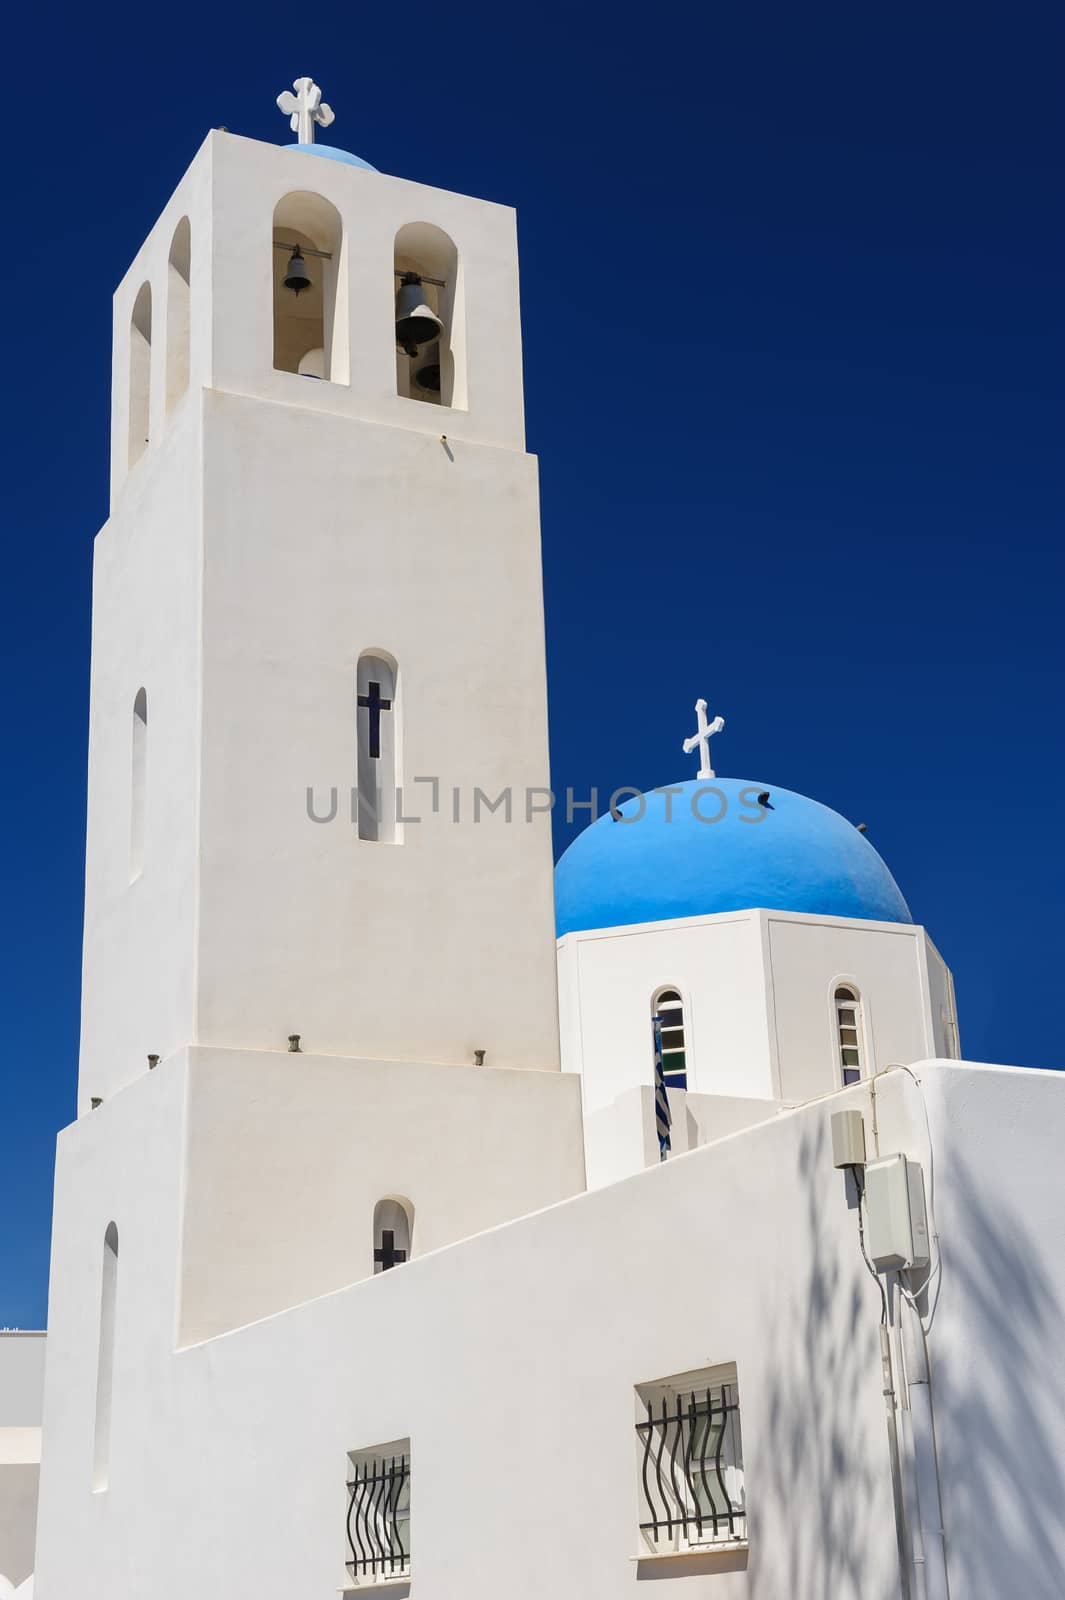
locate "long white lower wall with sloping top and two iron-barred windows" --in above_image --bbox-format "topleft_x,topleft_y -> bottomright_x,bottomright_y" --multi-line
37,1064 -> 1065,1600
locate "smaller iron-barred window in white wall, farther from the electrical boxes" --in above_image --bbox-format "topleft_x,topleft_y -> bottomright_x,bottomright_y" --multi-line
345,1438 -> 411,1589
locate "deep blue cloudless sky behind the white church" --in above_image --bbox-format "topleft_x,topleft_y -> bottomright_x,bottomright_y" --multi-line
0,0 -> 1065,1326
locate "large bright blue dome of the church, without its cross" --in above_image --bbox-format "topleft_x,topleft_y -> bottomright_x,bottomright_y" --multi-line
555,778 -> 913,938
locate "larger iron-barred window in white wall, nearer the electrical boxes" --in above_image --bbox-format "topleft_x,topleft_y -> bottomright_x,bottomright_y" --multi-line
636,1366 -> 747,1555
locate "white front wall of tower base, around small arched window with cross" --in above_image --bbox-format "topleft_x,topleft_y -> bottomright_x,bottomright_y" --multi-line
177,1050 -> 584,1344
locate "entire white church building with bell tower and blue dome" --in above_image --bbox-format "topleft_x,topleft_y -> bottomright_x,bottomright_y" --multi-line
0,78 -> 1065,1600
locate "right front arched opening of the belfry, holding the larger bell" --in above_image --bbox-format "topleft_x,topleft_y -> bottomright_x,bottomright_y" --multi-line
392,222 -> 469,411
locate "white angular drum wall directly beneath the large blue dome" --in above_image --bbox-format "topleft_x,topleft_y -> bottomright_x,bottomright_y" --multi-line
558,910 -> 953,1168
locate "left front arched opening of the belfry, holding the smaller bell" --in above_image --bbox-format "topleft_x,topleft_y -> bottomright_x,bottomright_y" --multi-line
272,190 -> 349,384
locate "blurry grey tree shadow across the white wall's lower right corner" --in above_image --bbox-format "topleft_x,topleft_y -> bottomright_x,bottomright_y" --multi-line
748,1117 -> 1065,1600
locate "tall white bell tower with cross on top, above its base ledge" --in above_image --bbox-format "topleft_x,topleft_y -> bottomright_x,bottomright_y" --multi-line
78,78 -> 558,1110
